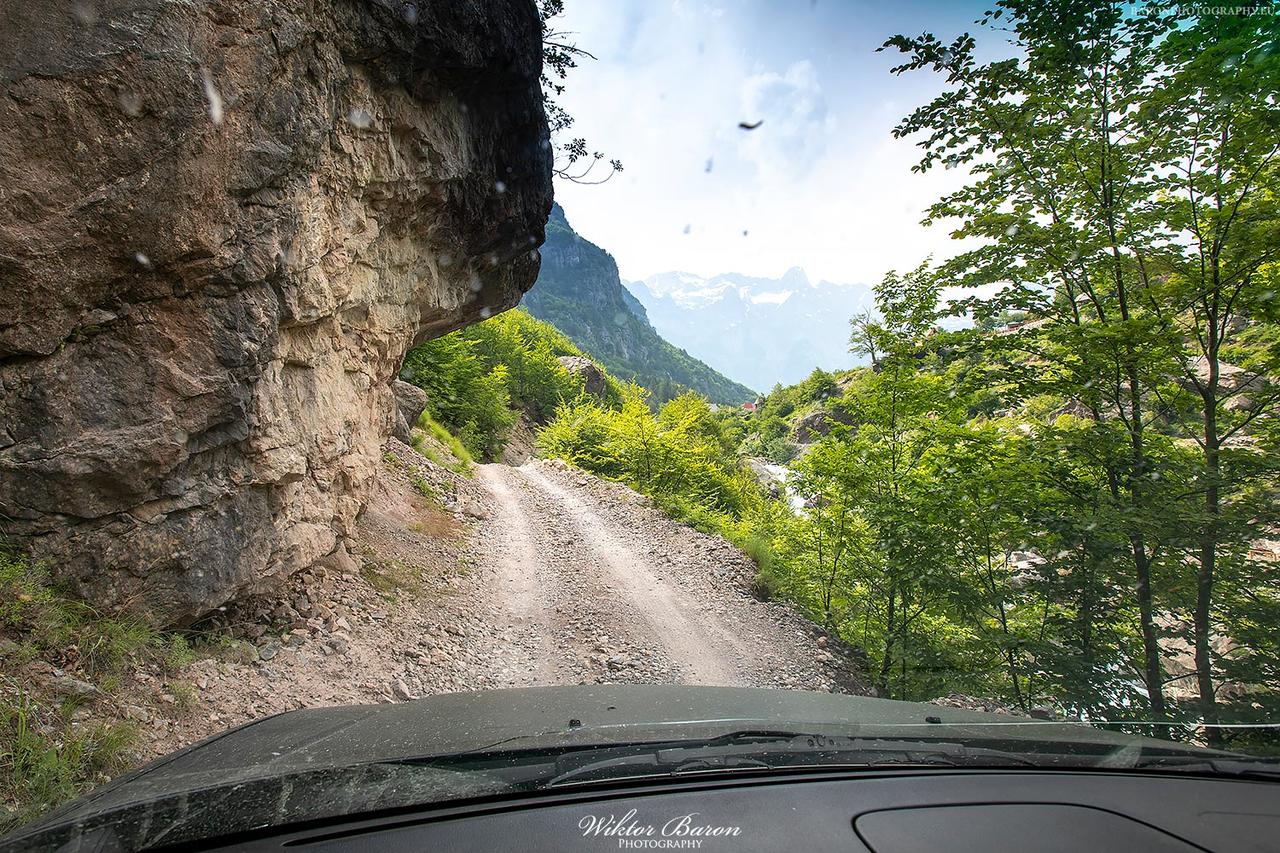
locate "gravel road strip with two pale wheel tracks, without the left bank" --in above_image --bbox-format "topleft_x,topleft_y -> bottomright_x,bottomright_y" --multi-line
475,461 -> 860,689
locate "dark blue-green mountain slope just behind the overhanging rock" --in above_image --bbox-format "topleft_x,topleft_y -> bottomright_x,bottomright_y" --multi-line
525,205 -> 755,405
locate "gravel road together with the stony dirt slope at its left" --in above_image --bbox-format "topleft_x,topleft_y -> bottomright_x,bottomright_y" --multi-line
132,442 -> 861,757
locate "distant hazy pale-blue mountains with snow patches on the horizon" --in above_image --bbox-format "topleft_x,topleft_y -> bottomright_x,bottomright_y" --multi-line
627,266 -> 873,389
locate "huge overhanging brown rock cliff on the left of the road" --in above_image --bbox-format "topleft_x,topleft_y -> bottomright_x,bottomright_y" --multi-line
0,0 -> 550,622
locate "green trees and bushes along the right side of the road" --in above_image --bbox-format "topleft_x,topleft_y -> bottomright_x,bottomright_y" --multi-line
407,3 -> 1280,747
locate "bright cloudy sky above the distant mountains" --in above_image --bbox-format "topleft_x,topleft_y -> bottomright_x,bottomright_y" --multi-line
556,0 -> 986,284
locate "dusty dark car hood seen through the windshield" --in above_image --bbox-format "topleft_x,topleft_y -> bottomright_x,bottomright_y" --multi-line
3,685 -> 1218,850
